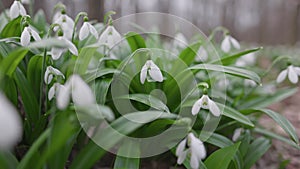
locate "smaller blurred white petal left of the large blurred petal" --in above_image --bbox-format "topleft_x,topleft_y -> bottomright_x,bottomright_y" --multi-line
56,83 -> 71,110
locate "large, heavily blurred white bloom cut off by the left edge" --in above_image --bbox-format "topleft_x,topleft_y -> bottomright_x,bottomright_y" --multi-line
0,92 -> 22,150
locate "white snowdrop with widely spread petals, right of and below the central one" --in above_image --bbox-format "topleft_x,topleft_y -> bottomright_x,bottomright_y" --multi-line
192,95 -> 221,117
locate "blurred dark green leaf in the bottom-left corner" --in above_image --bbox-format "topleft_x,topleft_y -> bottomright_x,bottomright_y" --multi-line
0,151 -> 19,169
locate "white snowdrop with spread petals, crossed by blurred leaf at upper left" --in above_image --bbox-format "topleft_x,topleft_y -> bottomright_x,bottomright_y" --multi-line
51,36 -> 78,60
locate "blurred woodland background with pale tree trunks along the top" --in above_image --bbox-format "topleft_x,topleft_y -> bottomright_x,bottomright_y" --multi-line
0,0 -> 300,45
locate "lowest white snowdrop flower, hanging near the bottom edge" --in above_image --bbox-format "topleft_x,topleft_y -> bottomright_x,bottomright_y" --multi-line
176,133 -> 206,169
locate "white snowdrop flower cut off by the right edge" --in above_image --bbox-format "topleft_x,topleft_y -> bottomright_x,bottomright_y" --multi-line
276,65 -> 300,84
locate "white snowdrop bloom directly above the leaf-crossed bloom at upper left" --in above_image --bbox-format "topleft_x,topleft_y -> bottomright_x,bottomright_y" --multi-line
53,13 -> 75,39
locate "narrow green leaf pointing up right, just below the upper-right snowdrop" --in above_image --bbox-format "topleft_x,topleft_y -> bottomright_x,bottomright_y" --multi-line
210,47 -> 263,66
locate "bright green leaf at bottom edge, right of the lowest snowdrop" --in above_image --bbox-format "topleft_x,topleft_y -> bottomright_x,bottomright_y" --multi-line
204,143 -> 240,169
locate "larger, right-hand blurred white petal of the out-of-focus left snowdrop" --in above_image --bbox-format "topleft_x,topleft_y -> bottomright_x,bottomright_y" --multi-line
70,75 -> 96,106
